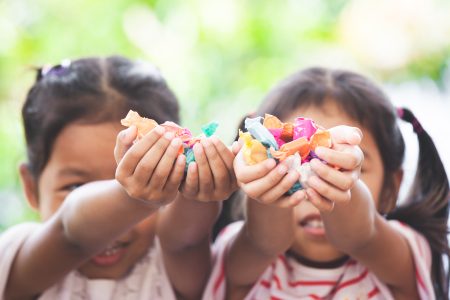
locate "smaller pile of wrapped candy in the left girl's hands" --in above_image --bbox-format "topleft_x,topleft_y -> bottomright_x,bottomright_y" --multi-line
120,110 -> 219,168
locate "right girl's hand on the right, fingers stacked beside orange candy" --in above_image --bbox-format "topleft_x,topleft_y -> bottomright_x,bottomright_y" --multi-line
306,126 -> 364,211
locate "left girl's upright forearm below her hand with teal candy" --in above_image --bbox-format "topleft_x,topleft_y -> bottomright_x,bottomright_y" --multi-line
157,194 -> 221,299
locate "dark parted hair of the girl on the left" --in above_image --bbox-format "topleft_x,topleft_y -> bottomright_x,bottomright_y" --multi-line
22,56 -> 179,179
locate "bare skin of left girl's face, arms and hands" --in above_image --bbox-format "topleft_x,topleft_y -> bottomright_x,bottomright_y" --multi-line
5,123 -> 236,299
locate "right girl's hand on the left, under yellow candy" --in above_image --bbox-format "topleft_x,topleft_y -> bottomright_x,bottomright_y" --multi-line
234,151 -> 305,207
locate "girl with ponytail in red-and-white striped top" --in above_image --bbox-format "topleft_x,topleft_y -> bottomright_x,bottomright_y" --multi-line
204,68 -> 449,299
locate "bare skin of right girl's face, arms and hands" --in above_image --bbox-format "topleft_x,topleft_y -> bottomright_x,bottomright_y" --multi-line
226,100 -> 418,299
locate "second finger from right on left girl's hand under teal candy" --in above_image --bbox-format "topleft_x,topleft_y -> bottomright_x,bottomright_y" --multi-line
201,138 -> 232,189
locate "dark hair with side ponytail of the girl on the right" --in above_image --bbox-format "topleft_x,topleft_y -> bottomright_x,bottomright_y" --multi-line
244,68 -> 450,299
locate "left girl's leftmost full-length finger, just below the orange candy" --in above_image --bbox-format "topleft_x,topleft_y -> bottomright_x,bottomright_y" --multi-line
116,126 -> 164,178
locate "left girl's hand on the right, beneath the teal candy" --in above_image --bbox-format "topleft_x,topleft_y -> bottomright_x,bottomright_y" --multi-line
181,136 -> 237,202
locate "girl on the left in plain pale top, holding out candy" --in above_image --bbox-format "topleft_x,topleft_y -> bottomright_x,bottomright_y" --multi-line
0,56 -> 236,300
